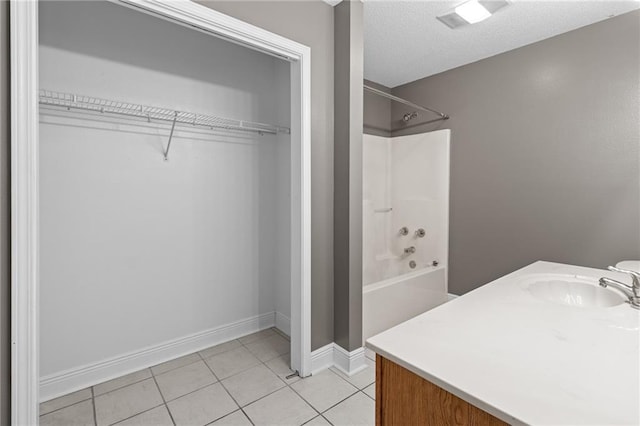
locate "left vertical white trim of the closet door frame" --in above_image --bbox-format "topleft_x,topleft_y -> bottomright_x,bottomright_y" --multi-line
9,1 -> 39,425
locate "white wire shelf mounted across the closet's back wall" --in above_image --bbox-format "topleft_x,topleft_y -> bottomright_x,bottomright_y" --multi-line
40,89 -> 291,134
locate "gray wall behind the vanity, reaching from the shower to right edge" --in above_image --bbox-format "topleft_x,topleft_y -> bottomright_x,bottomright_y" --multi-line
392,11 -> 640,294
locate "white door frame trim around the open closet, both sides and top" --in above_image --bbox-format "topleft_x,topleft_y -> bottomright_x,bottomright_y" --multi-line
10,0 -> 311,425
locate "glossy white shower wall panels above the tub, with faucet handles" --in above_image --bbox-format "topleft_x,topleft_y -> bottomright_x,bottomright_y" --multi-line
363,130 -> 450,285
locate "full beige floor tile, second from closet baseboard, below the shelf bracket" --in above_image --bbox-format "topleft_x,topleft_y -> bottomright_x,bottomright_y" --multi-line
156,361 -> 218,401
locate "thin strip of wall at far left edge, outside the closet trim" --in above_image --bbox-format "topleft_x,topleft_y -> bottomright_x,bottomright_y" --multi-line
0,0 -> 11,425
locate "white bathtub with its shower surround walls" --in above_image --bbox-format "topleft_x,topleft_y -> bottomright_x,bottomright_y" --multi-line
362,129 -> 451,339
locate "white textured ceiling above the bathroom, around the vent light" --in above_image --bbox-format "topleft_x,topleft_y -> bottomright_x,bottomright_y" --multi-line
364,0 -> 640,87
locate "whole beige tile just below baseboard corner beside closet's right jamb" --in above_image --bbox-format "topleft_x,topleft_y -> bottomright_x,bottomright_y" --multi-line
291,370 -> 358,413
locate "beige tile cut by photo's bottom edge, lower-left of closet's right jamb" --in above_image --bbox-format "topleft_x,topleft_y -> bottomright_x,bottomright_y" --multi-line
244,387 -> 318,426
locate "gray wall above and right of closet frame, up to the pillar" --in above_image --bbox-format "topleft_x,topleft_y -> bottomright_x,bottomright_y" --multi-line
195,0 -> 333,349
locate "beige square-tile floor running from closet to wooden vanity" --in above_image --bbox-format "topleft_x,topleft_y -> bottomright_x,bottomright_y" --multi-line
40,329 -> 375,426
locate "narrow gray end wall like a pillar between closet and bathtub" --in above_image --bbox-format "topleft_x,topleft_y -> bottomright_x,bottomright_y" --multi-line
333,1 -> 364,351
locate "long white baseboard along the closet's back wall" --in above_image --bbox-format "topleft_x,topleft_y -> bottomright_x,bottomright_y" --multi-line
40,312 -> 278,402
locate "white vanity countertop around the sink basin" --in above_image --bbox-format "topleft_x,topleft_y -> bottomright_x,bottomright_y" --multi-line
366,262 -> 640,426
